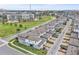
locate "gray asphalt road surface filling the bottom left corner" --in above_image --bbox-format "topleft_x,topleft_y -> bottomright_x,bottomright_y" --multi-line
0,45 -> 24,55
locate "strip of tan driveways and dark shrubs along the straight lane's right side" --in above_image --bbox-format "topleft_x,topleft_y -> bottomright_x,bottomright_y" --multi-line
57,26 -> 71,55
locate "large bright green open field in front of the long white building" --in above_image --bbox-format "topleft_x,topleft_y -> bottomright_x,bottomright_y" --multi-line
0,16 -> 51,37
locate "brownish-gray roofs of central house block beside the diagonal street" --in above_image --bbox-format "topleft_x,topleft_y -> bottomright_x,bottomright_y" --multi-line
19,17 -> 64,46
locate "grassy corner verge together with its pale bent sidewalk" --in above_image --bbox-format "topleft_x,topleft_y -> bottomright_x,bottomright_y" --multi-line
8,39 -> 47,55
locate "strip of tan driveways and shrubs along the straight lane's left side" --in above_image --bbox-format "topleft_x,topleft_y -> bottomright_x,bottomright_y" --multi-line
44,18 -> 65,51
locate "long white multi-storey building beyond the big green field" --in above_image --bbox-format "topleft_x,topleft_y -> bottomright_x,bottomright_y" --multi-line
7,13 -> 35,21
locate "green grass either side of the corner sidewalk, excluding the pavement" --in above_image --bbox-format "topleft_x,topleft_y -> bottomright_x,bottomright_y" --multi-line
9,40 -> 47,55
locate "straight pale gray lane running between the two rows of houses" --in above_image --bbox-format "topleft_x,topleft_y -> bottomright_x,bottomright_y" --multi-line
47,20 -> 72,55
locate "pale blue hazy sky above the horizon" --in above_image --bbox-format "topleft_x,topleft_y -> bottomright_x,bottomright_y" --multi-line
0,4 -> 79,10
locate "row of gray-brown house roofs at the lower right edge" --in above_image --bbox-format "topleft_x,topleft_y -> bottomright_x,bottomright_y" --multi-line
66,32 -> 79,55
